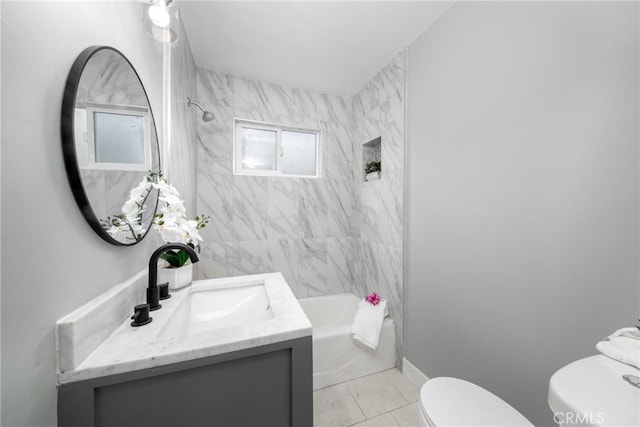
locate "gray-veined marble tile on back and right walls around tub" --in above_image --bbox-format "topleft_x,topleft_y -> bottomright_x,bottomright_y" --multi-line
196,52 -> 405,360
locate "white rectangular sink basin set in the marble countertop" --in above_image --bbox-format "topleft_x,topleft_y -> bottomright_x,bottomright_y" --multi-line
158,283 -> 273,338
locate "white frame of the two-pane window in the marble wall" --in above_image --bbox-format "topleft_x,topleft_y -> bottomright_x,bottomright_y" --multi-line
233,118 -> 322,178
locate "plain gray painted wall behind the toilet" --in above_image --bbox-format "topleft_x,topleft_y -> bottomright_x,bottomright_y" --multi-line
405,2 -> 639,425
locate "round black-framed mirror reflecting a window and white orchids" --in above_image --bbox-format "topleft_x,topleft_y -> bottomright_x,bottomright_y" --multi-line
61,46 -> 160,245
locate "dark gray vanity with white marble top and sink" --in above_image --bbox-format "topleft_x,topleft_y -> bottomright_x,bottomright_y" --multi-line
56,273 -> 313,427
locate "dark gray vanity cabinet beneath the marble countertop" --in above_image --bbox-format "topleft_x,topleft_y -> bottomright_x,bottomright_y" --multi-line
58,337 -> 313,427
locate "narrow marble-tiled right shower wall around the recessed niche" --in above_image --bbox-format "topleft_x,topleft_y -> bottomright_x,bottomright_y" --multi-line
352,51 -> 406,355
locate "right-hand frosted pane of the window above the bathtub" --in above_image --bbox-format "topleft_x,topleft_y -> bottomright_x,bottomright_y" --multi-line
282,130 -> 316,176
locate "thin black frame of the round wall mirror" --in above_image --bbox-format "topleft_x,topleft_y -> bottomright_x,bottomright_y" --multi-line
60,46 -> 162,246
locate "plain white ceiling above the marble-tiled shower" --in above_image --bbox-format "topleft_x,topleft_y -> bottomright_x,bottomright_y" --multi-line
178,0 -> 453,97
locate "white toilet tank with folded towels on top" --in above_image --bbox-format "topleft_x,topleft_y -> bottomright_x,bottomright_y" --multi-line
549,354 -> 640,427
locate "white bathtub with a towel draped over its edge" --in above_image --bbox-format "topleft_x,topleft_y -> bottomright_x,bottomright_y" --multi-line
298,293 -> 396,390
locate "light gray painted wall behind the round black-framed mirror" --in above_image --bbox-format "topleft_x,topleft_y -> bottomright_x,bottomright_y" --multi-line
1,1 -> 195,427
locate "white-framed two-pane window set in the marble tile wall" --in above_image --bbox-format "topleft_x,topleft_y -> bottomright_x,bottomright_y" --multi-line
233,119 -> 320,177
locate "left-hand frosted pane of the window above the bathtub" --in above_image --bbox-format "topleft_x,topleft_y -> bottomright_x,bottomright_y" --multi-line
242,127 -> 277,170
